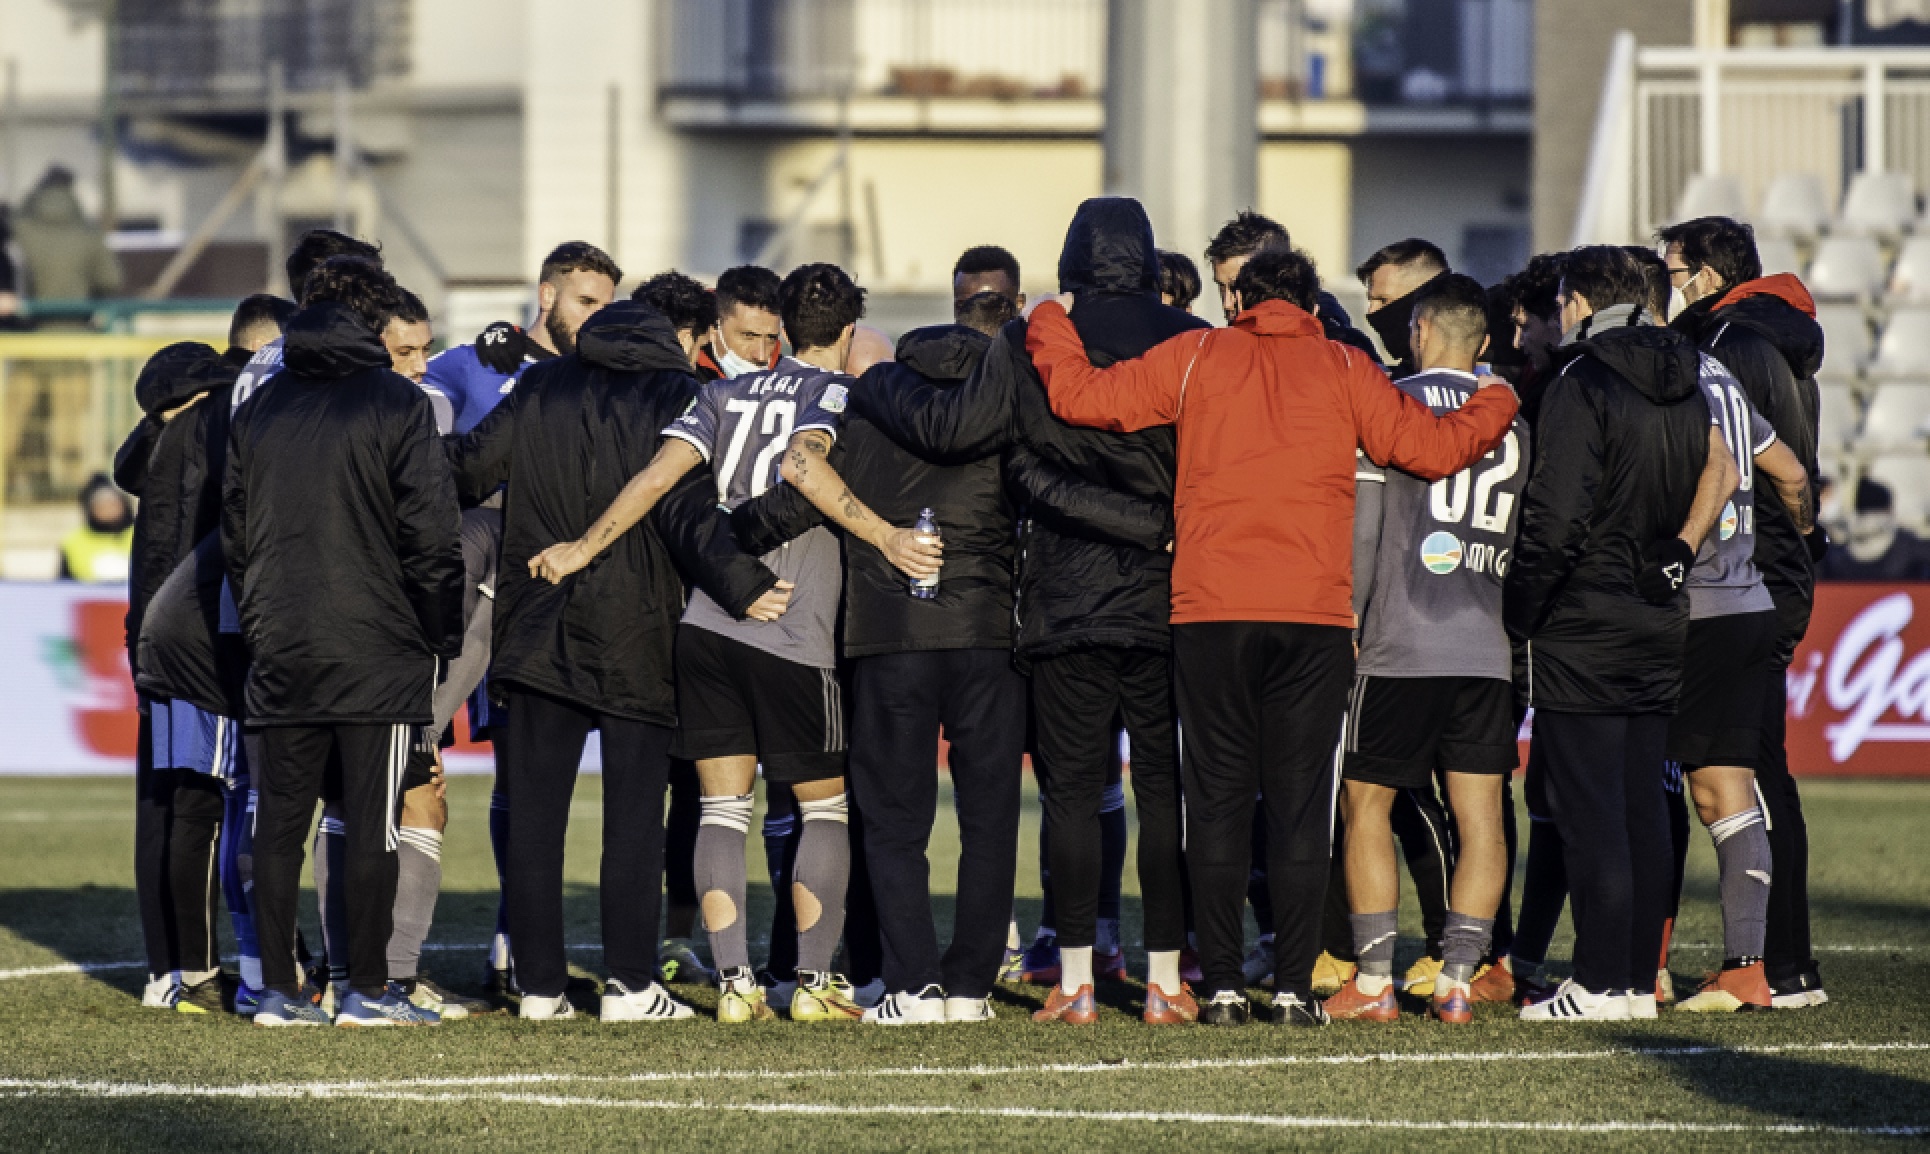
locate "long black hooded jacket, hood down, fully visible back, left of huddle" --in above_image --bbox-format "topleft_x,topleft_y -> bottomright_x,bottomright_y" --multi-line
222,303 -> 463,726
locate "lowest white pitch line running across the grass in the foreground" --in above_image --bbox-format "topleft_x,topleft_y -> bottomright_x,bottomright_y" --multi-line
0,1083 -> 1930,1139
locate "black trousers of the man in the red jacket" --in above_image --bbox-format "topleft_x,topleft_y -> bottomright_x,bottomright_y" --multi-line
1173,621 -> 1353,998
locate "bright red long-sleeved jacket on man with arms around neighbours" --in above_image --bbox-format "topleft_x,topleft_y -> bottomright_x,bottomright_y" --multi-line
1025,301 -> 1517,627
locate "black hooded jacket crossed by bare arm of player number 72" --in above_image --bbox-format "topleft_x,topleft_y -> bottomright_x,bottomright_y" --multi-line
444,301 -> 702,726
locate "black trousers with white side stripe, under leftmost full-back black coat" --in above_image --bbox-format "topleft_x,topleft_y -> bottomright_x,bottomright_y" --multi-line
255,726 -> 415,998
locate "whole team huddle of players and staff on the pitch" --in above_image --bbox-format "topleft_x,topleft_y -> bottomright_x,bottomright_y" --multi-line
116,197 -> 1828,1027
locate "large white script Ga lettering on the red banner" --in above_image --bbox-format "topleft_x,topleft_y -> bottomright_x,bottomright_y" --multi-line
1829,592 -> 1930,762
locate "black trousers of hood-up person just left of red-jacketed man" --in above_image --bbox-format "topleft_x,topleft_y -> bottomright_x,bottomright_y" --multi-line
1033,648 -> 1187,949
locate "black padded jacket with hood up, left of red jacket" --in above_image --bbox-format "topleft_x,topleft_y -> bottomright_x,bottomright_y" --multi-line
853,197 -> 1206,660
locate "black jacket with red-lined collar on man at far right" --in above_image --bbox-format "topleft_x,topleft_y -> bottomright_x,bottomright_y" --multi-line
1671,272 -> 1824,664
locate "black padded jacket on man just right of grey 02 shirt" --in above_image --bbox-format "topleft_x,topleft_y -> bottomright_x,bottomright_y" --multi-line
1503,316 -> 1708,714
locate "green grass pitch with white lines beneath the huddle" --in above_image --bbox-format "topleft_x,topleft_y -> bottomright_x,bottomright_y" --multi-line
0,778 -> 1930,1154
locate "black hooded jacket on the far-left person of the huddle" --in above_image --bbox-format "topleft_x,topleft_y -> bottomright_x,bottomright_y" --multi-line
114,342 -> 247,664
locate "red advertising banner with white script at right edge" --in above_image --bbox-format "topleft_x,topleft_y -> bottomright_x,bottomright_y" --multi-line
1789,583 -> 1930,778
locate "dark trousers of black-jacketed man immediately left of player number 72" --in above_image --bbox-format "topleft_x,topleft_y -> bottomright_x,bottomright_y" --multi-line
501,687 -> 672,998
